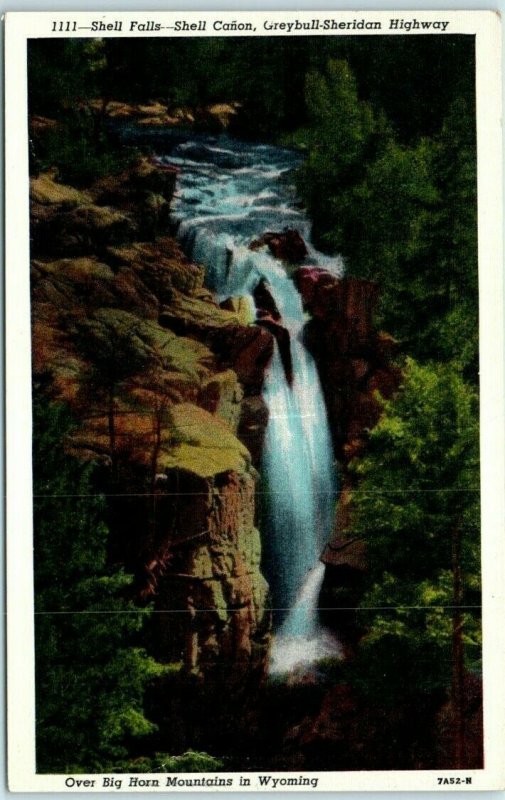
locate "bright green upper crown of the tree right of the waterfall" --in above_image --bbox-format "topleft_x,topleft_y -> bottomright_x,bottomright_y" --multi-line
348,359 -> 479,575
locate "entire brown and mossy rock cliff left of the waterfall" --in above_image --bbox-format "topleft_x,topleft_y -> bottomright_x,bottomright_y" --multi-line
31,159 -> 273,673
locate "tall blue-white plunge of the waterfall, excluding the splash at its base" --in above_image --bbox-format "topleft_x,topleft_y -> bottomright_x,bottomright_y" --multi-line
262,276 -> 335,608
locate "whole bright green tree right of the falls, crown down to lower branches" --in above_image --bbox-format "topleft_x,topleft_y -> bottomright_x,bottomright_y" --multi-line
346,360 -> 481,702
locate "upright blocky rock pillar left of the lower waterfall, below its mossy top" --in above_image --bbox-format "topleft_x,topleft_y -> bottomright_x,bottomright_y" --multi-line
146,471 -> 270,672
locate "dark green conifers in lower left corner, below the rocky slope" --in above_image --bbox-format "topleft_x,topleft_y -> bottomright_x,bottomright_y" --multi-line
33,395 -> 163,772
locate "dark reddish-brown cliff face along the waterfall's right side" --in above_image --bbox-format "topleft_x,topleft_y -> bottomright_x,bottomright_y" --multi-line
294,267 -> 401,644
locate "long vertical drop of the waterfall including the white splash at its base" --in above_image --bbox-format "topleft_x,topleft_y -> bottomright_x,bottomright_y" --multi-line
262,281 -> 340,673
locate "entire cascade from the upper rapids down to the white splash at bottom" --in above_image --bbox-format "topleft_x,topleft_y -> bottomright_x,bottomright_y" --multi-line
168,138 -> 341,672
